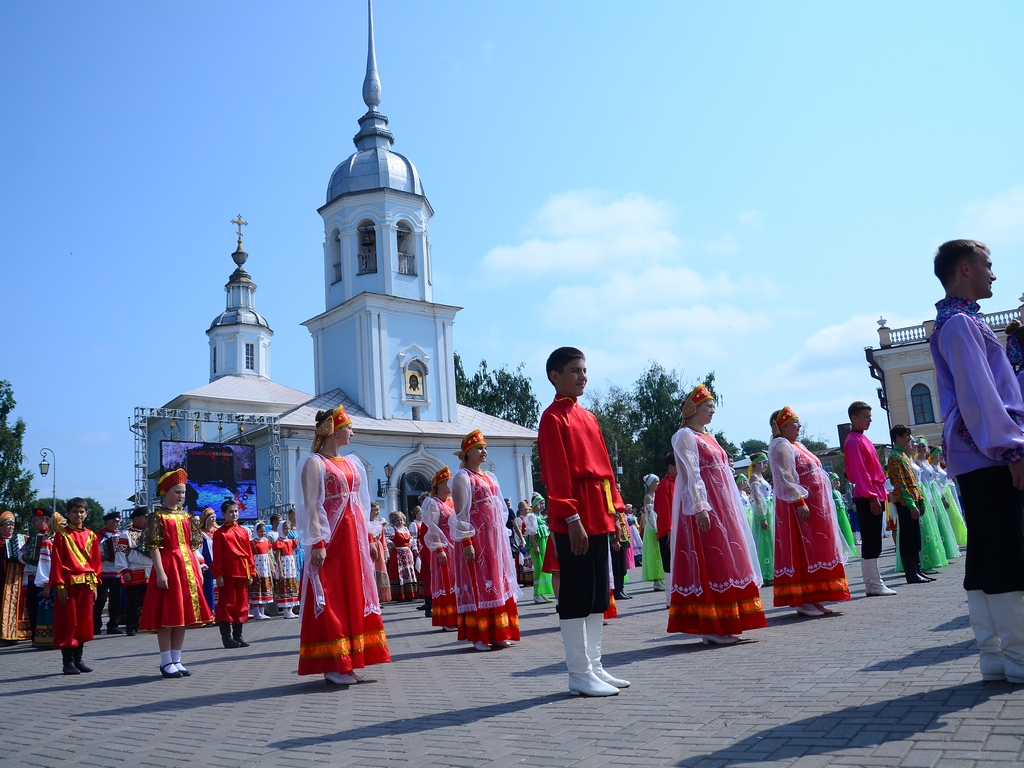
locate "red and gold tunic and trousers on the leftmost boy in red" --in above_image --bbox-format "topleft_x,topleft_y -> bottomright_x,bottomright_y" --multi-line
49,524 -> 102,648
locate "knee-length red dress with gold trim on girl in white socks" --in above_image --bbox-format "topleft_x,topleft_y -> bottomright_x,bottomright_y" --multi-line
138,507 -> 213,632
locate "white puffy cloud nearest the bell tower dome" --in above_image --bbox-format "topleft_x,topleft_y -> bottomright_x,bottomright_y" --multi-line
483,191 -> 682,276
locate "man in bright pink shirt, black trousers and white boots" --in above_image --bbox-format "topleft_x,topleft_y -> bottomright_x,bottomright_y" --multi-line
843,400 -> 896,597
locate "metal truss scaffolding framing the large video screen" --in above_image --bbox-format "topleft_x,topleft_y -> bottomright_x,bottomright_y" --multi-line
129,407 -> 287,514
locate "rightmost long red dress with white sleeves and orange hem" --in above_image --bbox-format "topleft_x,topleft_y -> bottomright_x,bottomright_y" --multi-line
770,437 -> 850,606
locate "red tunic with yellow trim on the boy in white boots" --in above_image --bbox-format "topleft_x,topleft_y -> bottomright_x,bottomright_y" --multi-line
537,396 -> 626,536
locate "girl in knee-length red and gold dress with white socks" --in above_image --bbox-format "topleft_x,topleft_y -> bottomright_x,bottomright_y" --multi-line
138,469 -> 213,678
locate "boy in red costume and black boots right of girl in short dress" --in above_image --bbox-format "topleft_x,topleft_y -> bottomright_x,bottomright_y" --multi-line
210,501 -> 256,648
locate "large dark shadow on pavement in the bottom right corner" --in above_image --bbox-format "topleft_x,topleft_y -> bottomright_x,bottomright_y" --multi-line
676,682 -> 1013,768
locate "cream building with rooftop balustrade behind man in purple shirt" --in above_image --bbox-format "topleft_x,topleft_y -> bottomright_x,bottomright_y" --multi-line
864,296 -> 1024,445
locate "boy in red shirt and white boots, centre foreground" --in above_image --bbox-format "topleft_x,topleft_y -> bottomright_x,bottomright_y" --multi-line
537,347 -> 629,696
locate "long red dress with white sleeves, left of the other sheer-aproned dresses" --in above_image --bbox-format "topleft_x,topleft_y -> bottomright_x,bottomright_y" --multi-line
296,454 -> 391,675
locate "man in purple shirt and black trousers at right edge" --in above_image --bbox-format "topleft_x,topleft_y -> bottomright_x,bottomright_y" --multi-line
930,240 -> 1024,683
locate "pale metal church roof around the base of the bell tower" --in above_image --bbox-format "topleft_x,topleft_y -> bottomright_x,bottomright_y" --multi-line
281,389 -> 537,440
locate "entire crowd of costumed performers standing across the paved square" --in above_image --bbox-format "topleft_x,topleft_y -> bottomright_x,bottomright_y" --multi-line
0,241 -> 1024,696
